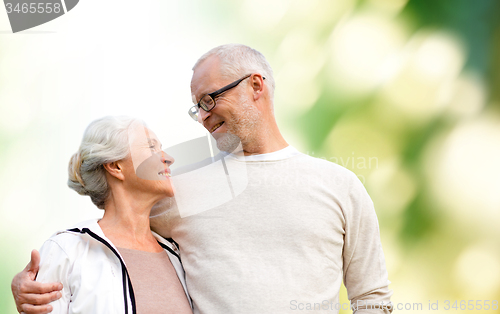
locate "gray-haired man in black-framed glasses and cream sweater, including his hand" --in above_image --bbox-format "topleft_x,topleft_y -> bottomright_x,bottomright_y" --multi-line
13,45 -> 392,314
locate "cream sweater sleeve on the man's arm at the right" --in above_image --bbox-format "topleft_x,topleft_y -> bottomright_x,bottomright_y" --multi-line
343,173 -> 392,314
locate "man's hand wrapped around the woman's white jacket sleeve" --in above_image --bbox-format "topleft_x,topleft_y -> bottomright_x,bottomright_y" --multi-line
11,250 -> 62,314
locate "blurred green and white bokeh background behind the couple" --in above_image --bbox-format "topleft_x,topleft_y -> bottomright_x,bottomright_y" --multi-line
0,0 -> 500,313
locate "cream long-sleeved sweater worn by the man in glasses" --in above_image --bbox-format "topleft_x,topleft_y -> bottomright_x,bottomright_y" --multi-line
151,146 -> 392,314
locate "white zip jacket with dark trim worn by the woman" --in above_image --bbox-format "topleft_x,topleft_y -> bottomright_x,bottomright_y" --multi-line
36,220 -> 192,314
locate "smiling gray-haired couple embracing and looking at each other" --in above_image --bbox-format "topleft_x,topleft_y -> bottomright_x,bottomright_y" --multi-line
12,44 -> 392,314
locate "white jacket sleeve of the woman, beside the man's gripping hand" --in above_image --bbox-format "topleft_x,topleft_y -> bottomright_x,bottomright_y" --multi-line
36,239 -> 72,314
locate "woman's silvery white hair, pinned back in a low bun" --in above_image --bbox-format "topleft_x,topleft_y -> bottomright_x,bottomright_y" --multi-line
68,116 -> 143,209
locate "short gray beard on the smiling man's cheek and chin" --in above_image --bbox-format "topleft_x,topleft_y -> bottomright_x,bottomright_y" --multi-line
217,100 -> 262,153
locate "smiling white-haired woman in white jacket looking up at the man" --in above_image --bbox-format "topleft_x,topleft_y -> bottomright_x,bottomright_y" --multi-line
28,117 -> 192,314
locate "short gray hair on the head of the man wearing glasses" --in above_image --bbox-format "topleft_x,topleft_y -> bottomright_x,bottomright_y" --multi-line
193,44 -> 275,99
